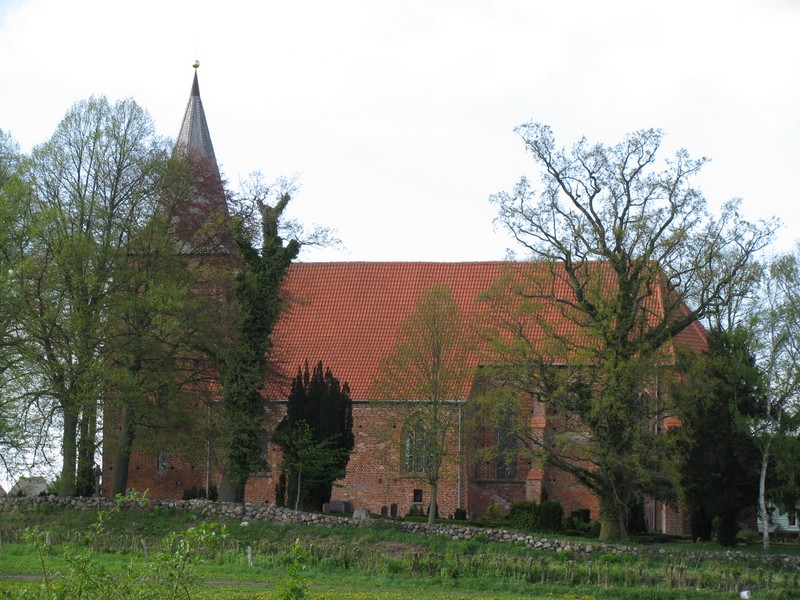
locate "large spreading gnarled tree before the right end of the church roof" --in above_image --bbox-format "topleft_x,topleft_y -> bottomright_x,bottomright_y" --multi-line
492,123 -> 772,540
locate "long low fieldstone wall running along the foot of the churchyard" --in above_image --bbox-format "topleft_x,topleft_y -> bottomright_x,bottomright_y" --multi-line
0,496 -> 800,570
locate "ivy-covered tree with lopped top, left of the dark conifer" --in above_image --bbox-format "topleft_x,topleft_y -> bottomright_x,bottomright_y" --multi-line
219,192 -> 300,502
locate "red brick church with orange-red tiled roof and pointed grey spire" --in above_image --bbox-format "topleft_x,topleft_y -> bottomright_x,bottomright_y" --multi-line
103,67 -> 705,532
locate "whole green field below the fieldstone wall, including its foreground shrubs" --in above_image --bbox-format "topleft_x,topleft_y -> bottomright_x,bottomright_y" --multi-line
0,505 -> 800,600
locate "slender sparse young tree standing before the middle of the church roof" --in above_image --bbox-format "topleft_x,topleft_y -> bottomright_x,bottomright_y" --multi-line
372,284 -> 474,524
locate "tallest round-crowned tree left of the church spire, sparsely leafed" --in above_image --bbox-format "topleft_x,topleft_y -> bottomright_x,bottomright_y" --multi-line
14,97 -> 168,495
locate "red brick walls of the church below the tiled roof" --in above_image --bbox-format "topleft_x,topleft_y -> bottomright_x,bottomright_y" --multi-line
103,402 -> 599,519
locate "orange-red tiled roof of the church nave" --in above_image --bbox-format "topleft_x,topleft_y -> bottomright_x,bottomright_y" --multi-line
270,262 -> 705,400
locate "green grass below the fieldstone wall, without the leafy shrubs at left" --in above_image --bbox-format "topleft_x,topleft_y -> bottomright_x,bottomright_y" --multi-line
0,505 -> 800,600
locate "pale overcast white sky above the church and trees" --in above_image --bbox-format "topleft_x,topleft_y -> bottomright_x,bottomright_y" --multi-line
0,0 -> 800,260
